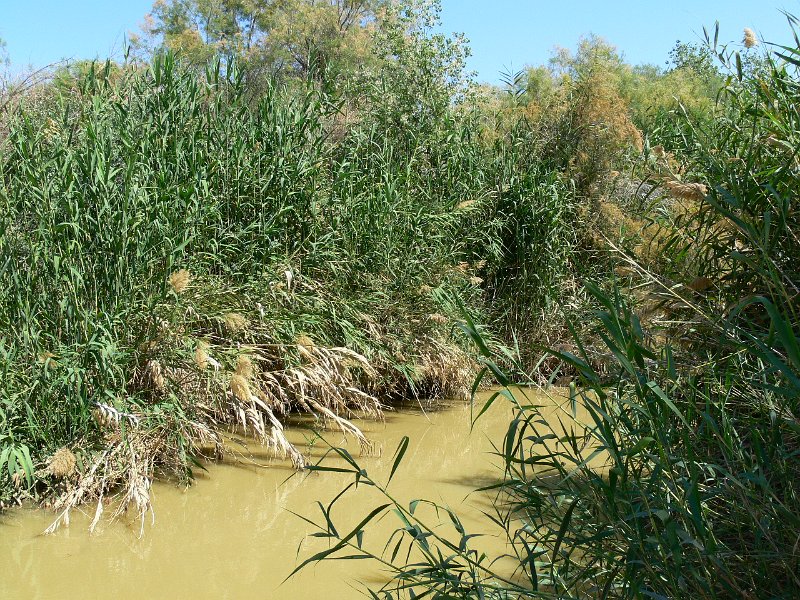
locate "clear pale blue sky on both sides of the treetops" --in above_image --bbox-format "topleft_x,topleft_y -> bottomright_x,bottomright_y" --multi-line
0,0 -> 800,82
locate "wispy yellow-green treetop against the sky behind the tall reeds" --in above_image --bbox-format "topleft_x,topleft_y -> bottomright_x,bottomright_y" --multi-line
136,0 -> 386,81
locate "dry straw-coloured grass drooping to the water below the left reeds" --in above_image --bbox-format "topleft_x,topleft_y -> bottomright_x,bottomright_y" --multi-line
42,263 -> 475,532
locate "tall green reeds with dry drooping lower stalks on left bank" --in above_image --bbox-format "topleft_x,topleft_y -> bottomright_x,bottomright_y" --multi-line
0,54 -> 573,520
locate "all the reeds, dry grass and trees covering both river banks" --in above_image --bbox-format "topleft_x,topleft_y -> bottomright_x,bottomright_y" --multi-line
0,0 -> 800,598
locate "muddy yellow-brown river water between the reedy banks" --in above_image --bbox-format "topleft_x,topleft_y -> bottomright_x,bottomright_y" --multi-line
0,390 -> 588,600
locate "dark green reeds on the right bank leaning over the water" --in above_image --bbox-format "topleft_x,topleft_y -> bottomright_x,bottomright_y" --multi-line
300,18 -> 800,599
